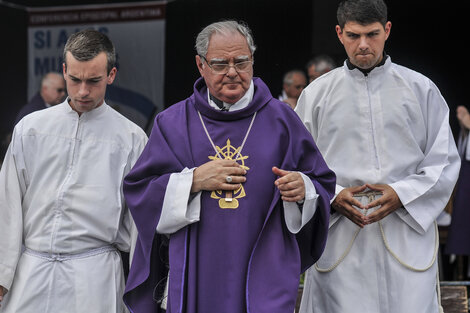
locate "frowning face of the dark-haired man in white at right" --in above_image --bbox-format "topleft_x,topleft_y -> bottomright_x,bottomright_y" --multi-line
336,22 -> 392,70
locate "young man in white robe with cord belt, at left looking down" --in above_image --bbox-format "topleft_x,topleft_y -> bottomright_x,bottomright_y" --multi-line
0,30 -> 147,313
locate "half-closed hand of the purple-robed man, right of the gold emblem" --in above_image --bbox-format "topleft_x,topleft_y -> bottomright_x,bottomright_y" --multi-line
272,166 -> 305,202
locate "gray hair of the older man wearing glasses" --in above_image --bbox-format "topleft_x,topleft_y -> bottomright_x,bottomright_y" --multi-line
195,20 -> 256,57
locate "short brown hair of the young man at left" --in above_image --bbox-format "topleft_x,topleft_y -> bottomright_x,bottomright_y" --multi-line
63,29 -> 116,74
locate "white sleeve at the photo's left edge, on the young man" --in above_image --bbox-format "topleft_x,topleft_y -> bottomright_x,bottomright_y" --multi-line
0,127 -> 26,289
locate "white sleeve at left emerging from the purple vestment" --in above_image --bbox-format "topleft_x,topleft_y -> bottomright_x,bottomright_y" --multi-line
157,168 -> 201,235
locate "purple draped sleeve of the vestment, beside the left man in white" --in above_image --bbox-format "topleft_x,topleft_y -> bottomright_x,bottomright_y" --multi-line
123,110 -> 194,312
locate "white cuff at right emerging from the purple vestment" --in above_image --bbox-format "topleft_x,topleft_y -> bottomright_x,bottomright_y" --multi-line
283,172 -> 318,234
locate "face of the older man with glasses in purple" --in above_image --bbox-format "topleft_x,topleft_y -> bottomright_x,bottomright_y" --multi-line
196,33 -> 253,104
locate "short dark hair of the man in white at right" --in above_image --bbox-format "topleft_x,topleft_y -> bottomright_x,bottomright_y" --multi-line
336,0 -> 387,29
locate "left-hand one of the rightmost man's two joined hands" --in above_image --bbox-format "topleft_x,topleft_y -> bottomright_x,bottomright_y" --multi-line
331,185 -> 367,228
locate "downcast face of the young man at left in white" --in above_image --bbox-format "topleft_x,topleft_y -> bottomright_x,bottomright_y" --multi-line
63,52 -> 117,115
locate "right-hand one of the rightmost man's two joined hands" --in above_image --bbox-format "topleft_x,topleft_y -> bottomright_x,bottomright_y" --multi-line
364,184 -> 403,224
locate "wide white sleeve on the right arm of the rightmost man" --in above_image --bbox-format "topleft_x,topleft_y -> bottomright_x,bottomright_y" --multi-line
390,85 -> 460,234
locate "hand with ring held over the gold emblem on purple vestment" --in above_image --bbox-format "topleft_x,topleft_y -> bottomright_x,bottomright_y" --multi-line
191,159 -> 246,193
